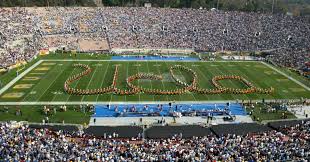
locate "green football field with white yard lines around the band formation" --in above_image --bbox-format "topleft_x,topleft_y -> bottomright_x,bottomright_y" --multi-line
0,58 -> 310,102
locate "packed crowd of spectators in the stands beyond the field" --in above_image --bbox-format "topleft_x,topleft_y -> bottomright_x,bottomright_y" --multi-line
0,7 -> 310,67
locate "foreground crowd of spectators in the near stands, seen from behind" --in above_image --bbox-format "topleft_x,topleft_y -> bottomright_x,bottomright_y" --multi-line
0,122 -> 310,161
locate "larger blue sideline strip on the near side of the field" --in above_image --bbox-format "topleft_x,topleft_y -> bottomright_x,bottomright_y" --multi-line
93,103 -> 246,117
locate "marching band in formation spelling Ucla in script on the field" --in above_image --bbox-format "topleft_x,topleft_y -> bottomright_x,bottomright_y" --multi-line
64,64 -> 274,95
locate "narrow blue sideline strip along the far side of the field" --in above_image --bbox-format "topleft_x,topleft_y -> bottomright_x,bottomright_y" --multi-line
112,56 -> 199,61
